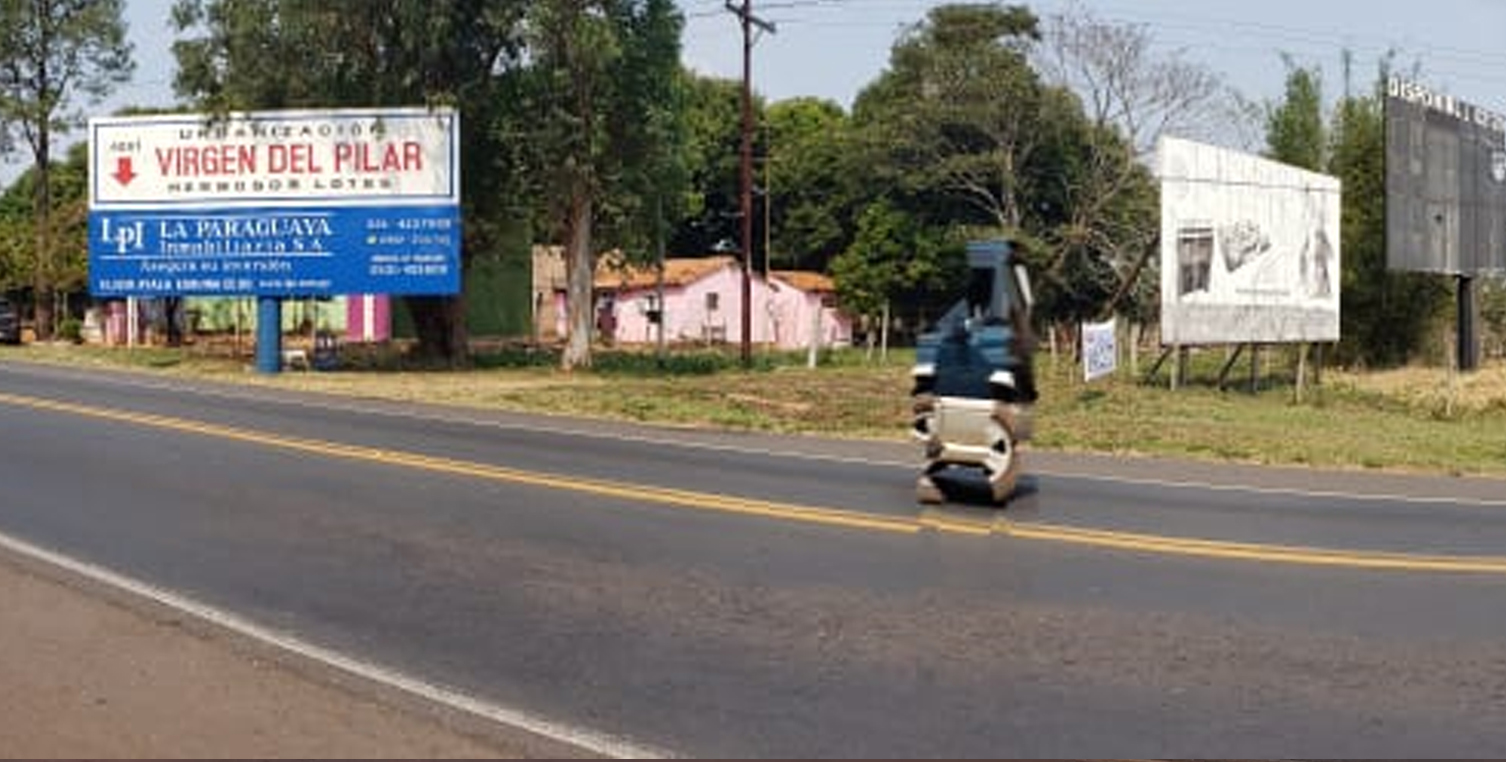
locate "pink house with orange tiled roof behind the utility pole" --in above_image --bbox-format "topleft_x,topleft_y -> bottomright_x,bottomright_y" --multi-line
595,256 -> 852,349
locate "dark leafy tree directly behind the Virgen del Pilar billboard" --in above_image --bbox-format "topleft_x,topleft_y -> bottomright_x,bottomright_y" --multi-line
173,0 -> 530,364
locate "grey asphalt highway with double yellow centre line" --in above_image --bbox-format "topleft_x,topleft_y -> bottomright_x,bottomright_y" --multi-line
0,361 -> 1506,757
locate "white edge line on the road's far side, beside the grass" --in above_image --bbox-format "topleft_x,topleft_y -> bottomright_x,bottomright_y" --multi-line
5,359 -> 1506,507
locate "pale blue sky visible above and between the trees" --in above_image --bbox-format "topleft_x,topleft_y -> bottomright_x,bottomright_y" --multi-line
20,0 -> 1506,164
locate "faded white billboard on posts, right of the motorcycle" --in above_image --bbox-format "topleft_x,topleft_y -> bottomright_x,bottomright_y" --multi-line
1160,137 -> 1340,345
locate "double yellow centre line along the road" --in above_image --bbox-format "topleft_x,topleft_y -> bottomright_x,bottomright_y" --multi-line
0,393 -> 1506,574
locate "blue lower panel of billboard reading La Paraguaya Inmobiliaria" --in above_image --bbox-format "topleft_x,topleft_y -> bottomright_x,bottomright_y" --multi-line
89,205 -> 461,297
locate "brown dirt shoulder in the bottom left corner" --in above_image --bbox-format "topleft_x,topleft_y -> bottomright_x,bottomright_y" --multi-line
0,551 -> 596,759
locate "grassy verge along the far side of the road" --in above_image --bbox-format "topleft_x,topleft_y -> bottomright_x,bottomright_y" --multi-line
0,345 -> 1506,476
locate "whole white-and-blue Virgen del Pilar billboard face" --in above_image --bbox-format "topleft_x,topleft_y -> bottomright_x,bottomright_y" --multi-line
89,108 -> 461,297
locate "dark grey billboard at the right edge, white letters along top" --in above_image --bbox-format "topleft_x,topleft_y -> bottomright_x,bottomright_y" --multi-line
1386,77 -> 1506,276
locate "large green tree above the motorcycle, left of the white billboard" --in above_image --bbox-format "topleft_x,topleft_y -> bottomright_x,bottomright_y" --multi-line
854,3 -> 1158,335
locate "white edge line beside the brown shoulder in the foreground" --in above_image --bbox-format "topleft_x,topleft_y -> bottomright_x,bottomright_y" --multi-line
0,533 -> 673,759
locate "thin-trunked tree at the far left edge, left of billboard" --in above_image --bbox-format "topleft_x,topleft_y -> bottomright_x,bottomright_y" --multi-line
0,0 -> 136,339
